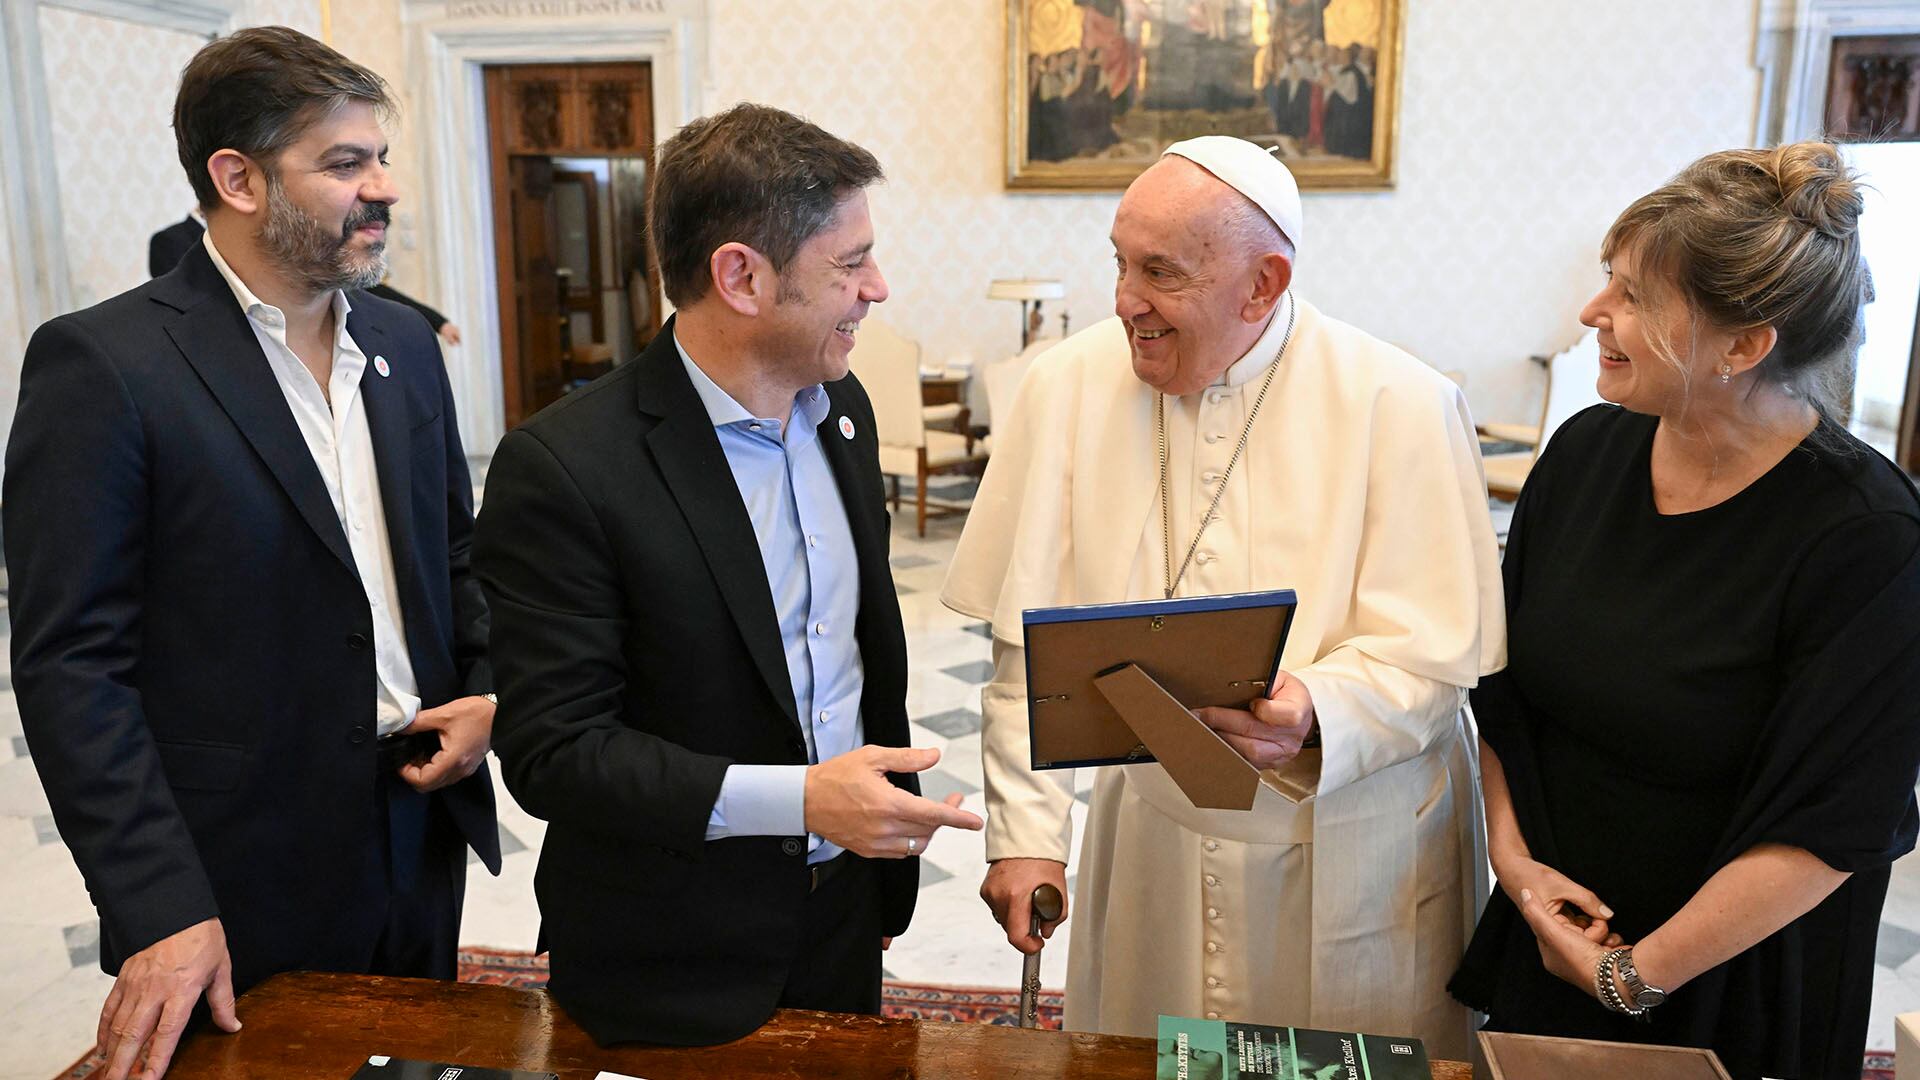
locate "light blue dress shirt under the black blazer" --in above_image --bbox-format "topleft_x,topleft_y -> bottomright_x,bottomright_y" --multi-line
674,338 -> 866,863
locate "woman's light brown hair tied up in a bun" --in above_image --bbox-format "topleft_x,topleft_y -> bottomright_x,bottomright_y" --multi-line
1601,140 -> 1872,421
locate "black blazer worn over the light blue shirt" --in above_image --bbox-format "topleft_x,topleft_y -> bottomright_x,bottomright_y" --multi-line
474,321 -> 920,1043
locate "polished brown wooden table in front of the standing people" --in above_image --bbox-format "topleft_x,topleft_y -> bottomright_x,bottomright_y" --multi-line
167,972 -> 1473,1080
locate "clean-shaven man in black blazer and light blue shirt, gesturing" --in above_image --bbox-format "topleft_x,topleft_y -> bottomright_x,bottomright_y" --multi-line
474,106 -> 981,1043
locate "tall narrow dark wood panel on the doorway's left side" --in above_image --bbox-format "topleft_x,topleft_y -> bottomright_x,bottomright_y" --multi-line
509,158 -> 566,417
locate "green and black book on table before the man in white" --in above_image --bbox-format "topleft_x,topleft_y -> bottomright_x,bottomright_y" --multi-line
1154,1017 -> 1432,1080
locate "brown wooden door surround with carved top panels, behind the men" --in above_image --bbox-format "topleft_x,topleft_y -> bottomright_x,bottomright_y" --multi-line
484,63 -> 655,429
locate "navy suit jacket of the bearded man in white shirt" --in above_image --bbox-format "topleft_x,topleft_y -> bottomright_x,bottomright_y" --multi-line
0,248 -> 499,988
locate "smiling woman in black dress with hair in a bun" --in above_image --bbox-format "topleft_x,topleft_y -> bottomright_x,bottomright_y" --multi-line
1452,142 -> 1920,1080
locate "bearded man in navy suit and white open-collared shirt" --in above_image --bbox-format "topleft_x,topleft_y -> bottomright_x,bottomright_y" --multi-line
0,27 -> 499,1080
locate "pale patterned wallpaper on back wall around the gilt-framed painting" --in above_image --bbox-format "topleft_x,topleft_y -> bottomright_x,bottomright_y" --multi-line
707,0 -> 1759,419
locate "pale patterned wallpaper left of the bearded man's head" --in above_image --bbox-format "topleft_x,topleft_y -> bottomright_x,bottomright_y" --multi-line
40,6 -> 204,307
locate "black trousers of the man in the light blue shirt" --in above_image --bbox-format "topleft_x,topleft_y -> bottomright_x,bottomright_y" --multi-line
780,851 -> 879,1017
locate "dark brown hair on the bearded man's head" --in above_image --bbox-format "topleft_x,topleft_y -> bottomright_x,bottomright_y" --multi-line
173,27 -> 396,209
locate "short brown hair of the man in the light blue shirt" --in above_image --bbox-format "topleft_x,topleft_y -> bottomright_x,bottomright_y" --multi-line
647,102 -> 885,307
